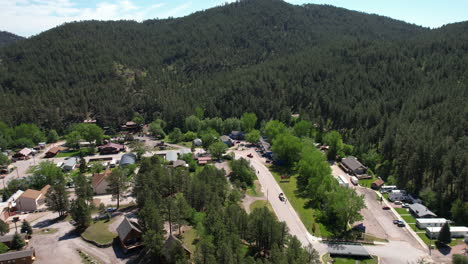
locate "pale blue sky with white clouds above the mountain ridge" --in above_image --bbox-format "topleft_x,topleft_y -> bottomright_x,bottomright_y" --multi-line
0,0 -> 468,36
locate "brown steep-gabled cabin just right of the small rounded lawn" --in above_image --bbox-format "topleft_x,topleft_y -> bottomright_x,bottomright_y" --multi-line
117,217 -> 143,252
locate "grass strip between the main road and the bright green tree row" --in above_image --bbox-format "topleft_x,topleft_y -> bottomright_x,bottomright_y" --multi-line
270,166 -> 331,237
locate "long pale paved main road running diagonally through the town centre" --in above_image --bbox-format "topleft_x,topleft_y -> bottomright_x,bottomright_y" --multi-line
234,149 -> 326,254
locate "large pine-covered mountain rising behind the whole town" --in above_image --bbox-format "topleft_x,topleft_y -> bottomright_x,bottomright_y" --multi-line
0,0 -> 468,218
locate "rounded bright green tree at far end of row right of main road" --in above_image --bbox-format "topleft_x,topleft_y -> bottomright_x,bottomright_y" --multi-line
272,133 -> 302,164
